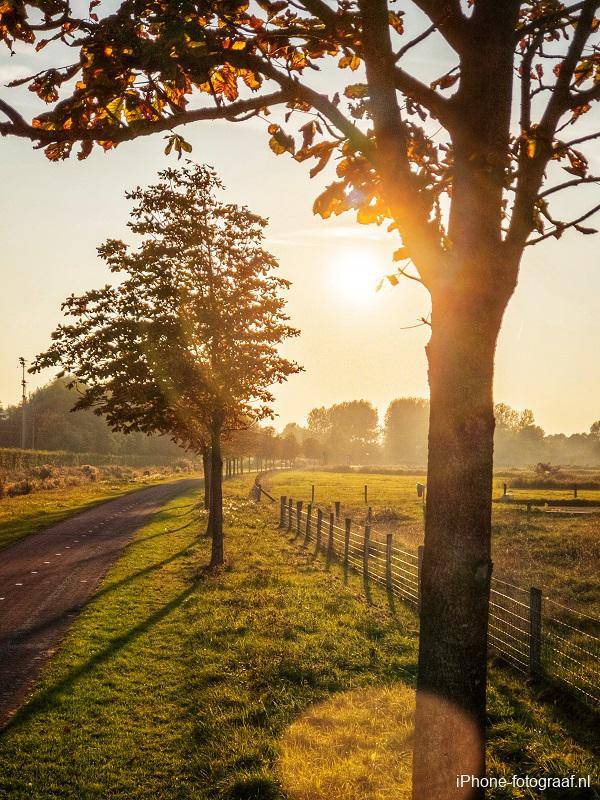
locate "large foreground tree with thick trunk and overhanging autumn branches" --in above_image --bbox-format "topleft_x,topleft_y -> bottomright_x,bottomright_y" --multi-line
0,0 -> 600,800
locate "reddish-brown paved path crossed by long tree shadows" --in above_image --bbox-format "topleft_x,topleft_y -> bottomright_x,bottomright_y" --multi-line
0,479 -> 201,730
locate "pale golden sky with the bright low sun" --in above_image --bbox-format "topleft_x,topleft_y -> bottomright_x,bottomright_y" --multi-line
0,6 -> 600,433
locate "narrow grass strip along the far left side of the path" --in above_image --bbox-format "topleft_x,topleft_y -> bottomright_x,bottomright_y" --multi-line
0,475 -> 199,549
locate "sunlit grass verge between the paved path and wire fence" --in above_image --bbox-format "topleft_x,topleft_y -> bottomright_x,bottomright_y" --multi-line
0,474 -> 598,800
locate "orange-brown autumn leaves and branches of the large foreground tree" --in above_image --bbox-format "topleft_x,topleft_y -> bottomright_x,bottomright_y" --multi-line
0,0 -> 600,286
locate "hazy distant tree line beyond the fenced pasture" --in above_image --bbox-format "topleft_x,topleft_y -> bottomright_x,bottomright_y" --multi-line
282,397 -> 600,467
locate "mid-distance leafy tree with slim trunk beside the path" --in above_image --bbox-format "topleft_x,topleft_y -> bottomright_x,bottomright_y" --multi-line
33,163 -> 299,566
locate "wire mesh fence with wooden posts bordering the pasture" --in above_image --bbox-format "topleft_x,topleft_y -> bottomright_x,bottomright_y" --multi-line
279,497 -> 600,706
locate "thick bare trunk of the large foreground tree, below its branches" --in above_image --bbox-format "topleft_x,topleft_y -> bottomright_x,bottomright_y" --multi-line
413,288 -> 508,800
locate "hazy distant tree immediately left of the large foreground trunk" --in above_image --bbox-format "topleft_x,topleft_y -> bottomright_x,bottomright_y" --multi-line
384,397 -> 429,464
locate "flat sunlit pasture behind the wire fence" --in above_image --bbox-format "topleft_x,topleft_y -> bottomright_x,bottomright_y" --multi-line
266,471 -> 600,616
